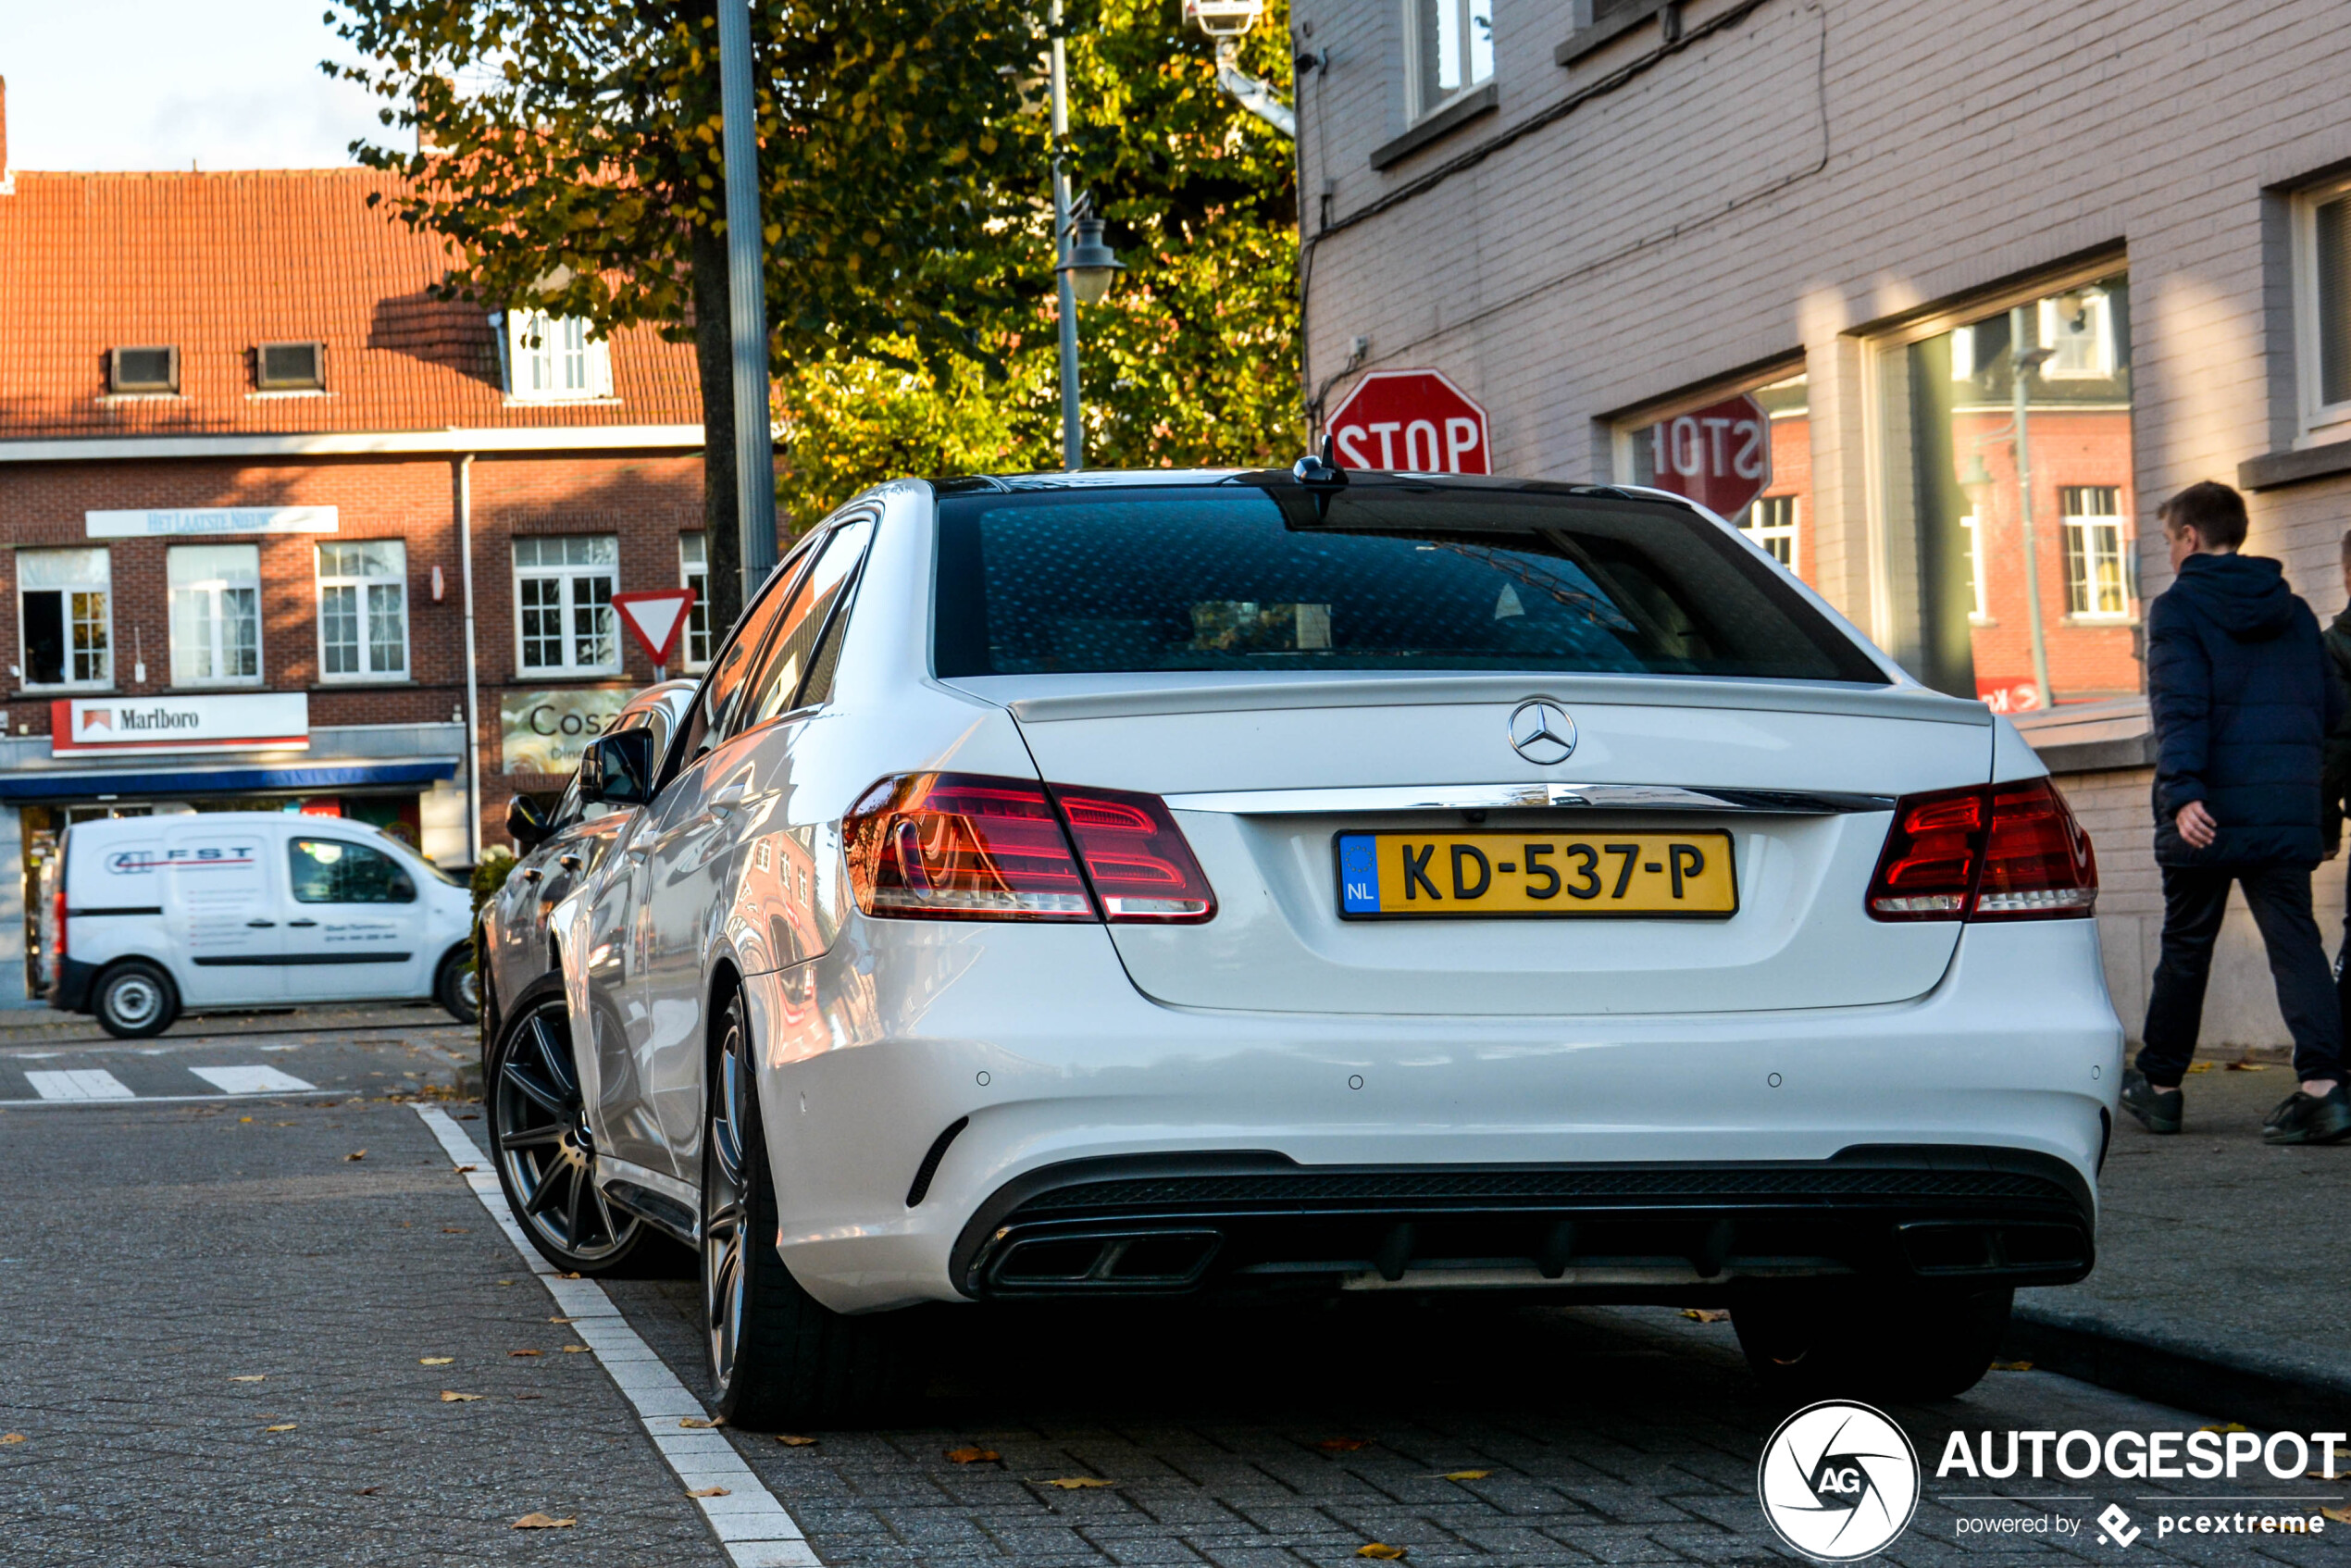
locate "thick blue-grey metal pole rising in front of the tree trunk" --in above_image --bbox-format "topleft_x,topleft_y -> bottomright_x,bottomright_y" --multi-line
713,0 -> 776,594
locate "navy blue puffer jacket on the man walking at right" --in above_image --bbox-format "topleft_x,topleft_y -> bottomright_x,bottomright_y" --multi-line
2146,554 -> 2344,865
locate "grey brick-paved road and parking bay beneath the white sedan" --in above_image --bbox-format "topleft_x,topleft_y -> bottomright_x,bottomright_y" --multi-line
0,1014 -> 2351,1568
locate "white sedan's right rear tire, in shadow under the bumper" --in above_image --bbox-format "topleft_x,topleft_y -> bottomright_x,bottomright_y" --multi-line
1730,1281 -> 2015,1401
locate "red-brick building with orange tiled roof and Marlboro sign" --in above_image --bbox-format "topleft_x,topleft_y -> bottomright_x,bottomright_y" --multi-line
0,101 -> 708,999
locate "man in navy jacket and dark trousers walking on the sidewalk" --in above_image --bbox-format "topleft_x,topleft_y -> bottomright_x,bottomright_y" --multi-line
2123,479 -> 2351,1142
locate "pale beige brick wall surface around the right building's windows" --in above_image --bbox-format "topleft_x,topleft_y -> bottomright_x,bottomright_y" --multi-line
1293,0 -> 2351,1044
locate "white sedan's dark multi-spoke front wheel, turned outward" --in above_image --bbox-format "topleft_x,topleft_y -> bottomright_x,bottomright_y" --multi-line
491,997 -> 640,1264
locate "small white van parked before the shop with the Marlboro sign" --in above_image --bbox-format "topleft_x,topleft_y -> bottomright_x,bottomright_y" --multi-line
40,811 -> 475,1039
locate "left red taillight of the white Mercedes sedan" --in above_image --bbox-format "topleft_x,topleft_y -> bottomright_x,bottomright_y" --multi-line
841,774 -> 1215,922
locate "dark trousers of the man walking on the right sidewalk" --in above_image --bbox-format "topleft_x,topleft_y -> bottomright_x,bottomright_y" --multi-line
2139,865 -> 2344,1089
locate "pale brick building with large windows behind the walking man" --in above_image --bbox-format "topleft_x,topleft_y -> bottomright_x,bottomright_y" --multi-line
1293,0 -> 2351,1044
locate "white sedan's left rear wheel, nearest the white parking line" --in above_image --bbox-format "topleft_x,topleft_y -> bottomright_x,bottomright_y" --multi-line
701,992 -> 913,1432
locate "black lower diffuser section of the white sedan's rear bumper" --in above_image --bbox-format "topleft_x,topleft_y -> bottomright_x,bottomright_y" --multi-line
950,1145 -> 2095,1300
